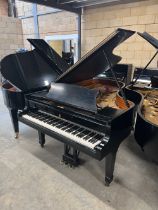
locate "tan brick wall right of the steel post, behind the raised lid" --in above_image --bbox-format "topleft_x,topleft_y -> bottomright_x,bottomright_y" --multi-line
82,0 -> 158,67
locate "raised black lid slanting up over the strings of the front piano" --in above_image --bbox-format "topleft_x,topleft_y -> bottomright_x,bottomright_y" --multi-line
56,29 -> 135,83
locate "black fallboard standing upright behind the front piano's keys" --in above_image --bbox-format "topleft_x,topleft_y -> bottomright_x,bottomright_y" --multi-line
27,97 -> 112,135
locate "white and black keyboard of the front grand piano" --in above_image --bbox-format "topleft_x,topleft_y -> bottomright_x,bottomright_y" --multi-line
22,111 -> 104,149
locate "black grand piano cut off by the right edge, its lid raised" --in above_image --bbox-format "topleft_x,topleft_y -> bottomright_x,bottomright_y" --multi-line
131,32 -> 158,163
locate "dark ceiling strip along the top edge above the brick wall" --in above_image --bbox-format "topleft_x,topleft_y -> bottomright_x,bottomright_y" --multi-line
20,0 -> 143,13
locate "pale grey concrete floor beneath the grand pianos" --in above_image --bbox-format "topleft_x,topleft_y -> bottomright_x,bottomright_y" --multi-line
0,91 -> 158,210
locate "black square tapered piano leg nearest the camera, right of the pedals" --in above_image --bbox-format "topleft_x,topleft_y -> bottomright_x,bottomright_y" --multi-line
105,151 -> 117,186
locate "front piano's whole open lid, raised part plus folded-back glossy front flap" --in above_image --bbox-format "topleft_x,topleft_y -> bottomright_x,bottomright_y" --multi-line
35,29 -> 135,113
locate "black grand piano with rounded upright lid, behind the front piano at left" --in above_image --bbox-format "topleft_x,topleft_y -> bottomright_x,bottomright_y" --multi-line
1,39 -> 69,138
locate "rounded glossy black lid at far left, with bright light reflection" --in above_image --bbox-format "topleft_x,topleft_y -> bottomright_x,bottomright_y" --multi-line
1,50 -> 59,92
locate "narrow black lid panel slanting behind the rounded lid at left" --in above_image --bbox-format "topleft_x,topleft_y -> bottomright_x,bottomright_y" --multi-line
27,39 -> 69,74
